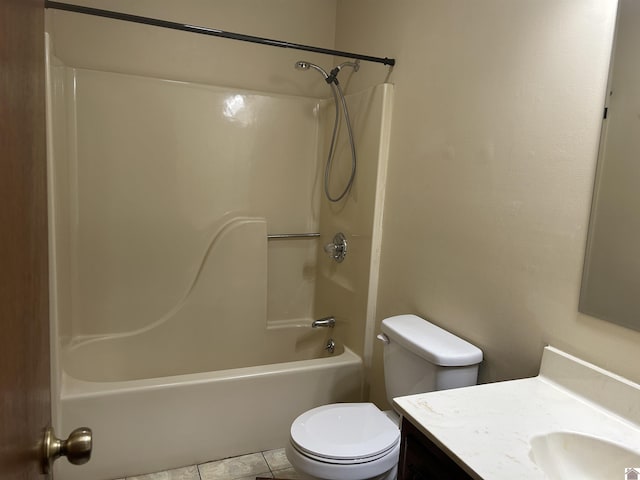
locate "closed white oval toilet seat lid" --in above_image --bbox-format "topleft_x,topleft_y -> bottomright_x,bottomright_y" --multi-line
291,403 -> 400,460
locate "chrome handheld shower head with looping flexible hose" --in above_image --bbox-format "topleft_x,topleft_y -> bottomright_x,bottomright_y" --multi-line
295,60 -> 360,202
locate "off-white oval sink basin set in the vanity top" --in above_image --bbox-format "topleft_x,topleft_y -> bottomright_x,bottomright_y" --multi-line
530,432 -> 640,480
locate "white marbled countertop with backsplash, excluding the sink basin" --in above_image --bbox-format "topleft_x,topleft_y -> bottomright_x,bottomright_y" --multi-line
394,347 -> 640,480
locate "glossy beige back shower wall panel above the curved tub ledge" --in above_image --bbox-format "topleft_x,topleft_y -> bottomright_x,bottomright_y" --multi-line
53,67 -> 319,339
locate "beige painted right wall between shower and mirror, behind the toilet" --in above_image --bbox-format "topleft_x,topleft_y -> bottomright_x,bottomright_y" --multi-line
336,0 -> 640,403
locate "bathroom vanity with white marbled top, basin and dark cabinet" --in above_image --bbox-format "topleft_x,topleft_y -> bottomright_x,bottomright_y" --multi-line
394,347 -> 640,480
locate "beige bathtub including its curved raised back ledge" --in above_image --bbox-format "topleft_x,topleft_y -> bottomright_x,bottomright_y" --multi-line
51,217 -> 362,480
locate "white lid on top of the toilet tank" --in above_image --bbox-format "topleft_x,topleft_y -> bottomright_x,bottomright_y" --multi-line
382,315 -> 482,367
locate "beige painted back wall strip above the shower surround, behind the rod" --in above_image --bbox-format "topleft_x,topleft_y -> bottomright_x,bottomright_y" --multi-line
47,0 -> 336,98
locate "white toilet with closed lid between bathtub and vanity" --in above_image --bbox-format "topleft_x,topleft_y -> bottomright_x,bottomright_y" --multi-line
285,315 -> 482,480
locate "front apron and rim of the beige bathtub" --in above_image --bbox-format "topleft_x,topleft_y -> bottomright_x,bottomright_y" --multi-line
56,347 -> 362,480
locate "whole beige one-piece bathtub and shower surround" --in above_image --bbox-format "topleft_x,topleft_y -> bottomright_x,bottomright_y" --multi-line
49,32 -> 389,480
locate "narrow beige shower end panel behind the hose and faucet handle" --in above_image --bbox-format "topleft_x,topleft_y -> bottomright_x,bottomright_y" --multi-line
315,84 -> 393,365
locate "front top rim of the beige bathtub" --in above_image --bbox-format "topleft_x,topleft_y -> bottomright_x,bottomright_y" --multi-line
60,345 -> 363,401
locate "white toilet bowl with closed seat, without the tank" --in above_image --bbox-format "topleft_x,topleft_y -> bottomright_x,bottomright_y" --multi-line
285,403 -> 400,480
